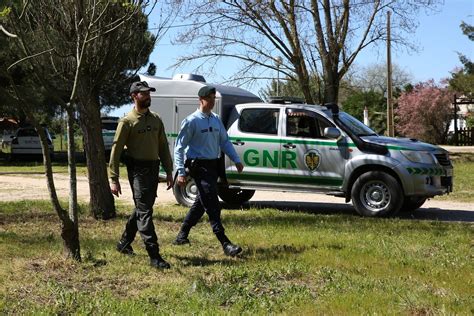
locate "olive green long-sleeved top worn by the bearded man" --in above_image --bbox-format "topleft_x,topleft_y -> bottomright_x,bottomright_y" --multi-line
109,108 -> 173,182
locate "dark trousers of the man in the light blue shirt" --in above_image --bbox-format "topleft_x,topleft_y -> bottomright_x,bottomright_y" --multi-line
183,159 -> 225,236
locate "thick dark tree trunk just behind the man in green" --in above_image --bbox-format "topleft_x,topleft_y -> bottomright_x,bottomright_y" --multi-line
78,89 -> 116,220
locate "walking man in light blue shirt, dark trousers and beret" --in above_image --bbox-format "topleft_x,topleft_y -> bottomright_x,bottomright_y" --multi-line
174,86 -> 244,256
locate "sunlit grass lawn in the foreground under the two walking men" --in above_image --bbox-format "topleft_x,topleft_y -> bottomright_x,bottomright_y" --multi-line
0,201 -> 474,315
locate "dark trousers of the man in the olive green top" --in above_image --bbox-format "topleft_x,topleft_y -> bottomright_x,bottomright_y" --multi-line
122,160 -> 160,255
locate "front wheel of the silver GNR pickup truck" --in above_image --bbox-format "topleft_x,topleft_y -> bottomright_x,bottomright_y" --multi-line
351,171 -> 404,217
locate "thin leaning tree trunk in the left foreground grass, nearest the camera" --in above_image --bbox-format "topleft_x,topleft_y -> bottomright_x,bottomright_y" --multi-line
28,116 -> 81,261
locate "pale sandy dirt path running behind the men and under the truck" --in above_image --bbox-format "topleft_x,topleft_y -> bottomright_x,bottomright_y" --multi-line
0,174 -> 474,211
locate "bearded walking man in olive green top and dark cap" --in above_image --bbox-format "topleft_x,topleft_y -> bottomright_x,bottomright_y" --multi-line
109,81 -> 173,269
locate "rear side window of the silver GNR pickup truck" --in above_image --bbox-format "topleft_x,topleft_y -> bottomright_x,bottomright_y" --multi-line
239,109 -> 280,135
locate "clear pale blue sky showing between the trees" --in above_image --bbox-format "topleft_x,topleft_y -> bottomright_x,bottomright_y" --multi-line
111,0 -> 474,116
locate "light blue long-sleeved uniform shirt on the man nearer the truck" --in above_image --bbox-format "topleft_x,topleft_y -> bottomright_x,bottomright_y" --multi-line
174,110 -> 240,176
